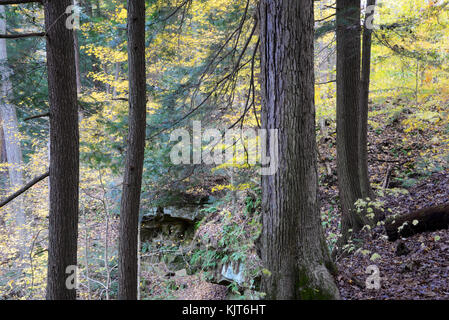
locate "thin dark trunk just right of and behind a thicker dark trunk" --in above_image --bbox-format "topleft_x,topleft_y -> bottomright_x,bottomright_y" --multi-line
358,0 -> 376,198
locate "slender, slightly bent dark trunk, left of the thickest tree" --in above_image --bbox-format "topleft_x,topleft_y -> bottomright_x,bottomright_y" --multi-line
118,0 -> 146,300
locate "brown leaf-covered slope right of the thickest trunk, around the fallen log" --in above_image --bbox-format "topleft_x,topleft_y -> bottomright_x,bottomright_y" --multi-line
320,103 -> 449,300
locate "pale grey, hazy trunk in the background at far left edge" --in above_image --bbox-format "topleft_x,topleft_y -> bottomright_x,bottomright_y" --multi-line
0,6 -> 27,255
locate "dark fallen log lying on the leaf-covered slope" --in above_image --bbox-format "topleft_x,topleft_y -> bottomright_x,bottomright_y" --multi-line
385,204 -> 449,241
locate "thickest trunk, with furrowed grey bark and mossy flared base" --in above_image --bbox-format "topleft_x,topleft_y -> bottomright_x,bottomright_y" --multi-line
260,0 -> 339,299
